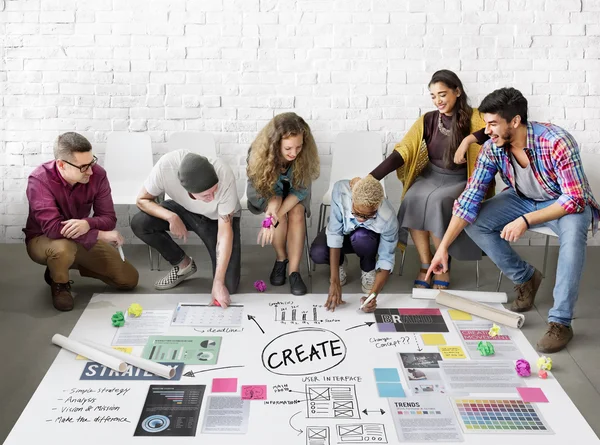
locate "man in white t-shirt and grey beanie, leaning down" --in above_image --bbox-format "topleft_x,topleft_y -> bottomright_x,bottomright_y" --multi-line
131,150 -> 241,307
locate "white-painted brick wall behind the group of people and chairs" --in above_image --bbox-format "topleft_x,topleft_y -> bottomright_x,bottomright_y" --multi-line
0,0 -> 600,244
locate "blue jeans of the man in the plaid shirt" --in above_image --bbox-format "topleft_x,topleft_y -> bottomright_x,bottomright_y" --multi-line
465,189 -> 592,326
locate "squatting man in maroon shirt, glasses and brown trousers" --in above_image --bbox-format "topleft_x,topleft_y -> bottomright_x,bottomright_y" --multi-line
23,132 -> 138,311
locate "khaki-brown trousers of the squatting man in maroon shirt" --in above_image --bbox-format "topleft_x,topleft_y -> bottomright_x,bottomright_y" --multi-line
27,235 -> 139,290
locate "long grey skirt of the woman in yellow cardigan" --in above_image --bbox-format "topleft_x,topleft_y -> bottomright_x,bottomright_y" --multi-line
398,163 -> 481,261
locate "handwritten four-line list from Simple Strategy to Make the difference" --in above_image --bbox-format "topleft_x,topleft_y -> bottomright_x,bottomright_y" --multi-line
51,386 -> 131,424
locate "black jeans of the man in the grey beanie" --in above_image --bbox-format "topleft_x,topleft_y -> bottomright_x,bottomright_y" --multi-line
131,200 -> 242,294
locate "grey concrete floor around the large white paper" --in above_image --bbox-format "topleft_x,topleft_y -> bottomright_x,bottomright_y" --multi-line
0,244 -> 600,442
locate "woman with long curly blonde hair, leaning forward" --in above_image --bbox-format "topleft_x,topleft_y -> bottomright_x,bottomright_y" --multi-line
246,113 -> 320,295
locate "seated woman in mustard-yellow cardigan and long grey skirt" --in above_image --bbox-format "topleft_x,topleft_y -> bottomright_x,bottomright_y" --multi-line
371,70 -> 487,289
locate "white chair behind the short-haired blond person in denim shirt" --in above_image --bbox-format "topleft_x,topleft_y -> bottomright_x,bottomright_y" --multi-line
312,131 -> 385,270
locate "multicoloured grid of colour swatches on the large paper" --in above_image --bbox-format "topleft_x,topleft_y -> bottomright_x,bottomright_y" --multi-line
454,399 -> 552,434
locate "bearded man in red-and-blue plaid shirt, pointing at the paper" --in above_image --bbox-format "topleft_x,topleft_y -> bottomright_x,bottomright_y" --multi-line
428,88 -> 600,353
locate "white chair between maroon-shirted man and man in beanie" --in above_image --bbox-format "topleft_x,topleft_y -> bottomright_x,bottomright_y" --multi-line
104,131 -> 154,270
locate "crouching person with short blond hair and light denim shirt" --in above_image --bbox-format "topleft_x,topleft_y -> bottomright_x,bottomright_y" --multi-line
310,175 -> 398,312
